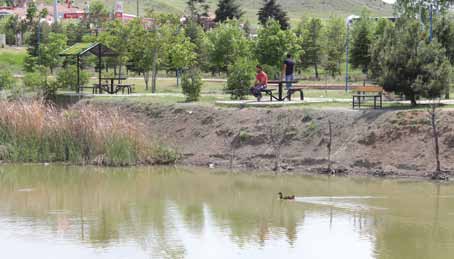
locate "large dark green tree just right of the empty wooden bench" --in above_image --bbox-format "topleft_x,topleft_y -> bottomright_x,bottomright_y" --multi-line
373,17 -> 451,105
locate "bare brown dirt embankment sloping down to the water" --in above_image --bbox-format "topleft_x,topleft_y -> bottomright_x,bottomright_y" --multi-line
84,103 -> 454,179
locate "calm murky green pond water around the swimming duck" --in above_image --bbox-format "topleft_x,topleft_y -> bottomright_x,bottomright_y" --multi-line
0,166 -> 454,259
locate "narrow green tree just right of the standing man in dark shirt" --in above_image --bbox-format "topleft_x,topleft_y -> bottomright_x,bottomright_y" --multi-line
301,18 -> 323,79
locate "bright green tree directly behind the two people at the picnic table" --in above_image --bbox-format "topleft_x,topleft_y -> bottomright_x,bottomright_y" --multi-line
255,20 -> 302,77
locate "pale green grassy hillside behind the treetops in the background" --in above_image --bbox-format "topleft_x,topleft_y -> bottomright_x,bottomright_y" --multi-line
76,0 -> 392,21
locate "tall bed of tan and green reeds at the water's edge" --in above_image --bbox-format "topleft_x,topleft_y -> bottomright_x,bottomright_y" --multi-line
0,101 -> 178,166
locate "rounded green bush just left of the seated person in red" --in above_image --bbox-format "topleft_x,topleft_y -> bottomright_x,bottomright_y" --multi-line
225,58 -> 255,99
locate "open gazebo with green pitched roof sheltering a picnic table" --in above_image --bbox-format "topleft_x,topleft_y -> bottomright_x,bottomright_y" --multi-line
60,42 -> 118,92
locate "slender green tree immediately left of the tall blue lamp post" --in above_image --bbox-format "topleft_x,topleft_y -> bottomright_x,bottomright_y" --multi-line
323,17 -> 346,77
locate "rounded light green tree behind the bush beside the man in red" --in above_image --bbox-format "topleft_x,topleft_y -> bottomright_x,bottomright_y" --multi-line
207,21 -> 251,72
